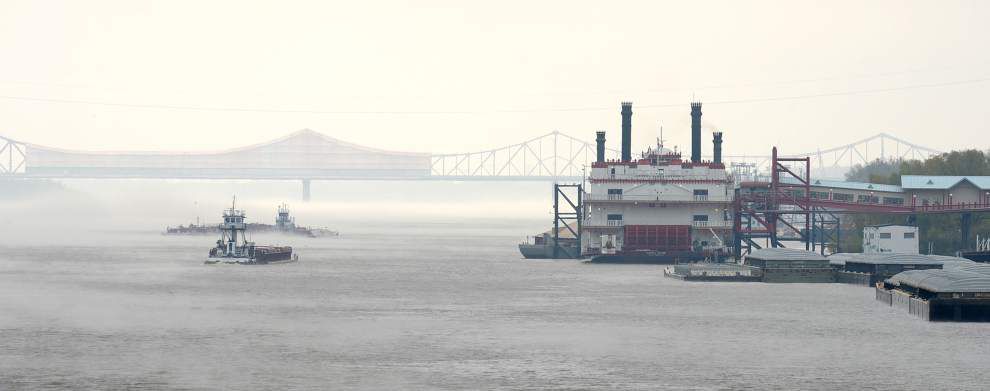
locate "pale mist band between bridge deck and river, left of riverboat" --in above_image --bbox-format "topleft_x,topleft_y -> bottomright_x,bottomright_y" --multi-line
0,180 -> 552,246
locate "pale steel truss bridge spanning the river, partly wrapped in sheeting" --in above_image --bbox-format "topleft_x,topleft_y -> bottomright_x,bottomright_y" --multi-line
0,129 -> 940,199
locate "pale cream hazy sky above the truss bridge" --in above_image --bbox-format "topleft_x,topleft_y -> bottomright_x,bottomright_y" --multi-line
0,0 -> 990,158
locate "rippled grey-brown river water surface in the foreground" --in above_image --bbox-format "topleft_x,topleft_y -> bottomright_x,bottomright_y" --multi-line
0,221 -> 990,390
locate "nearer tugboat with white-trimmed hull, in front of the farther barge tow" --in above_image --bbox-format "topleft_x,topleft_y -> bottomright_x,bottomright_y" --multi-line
205,198 -> 299,265
